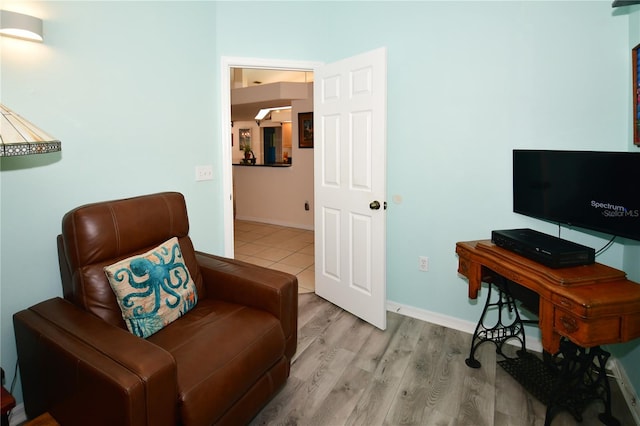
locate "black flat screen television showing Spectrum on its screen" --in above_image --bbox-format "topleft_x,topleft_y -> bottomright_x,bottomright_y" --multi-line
513,149 -> 640,241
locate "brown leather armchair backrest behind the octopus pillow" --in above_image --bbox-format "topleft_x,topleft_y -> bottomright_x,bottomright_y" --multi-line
59,192 -> 207,329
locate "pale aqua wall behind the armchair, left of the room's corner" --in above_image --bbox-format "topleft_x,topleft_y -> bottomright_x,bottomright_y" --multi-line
0,1 -> 223,401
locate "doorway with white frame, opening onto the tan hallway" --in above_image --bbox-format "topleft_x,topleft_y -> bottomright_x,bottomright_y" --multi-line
221,58 -> 319,291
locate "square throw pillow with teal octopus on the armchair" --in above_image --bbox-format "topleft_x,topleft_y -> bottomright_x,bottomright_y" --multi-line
104,237 -> 198,338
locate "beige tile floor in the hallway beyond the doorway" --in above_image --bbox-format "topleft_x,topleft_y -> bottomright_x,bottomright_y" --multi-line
234,220 -> 315,293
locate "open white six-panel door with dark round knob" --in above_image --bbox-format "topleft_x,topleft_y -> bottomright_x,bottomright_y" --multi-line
314,48 -> 387,330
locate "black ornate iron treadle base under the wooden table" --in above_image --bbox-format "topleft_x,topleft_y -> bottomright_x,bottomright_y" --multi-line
465,275 -> 620,426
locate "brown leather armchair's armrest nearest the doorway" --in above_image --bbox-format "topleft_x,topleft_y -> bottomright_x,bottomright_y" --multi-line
196,252 -> 298,359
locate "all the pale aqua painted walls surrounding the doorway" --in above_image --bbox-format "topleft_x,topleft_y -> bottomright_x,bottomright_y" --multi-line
0,0 -> 640,404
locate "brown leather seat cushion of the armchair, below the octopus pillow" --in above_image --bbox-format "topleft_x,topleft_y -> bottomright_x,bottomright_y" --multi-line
148,299 -> 285,424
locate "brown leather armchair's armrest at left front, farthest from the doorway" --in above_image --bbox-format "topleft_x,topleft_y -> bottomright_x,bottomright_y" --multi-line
13,298 -> 178,426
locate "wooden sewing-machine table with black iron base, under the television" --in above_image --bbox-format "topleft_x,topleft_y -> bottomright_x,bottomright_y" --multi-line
456,240 -> 640,425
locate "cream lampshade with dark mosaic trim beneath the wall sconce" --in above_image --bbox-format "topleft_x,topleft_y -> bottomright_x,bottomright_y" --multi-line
0,104 -> 62,157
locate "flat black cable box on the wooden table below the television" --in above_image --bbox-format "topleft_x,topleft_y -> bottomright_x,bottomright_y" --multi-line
491,228 -> 595,268
